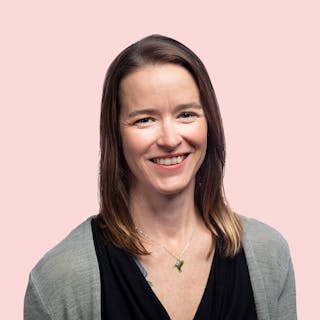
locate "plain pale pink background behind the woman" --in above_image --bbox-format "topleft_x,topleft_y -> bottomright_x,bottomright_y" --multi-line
0,0 -> 320,319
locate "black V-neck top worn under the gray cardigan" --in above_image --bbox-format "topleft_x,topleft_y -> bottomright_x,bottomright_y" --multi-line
91,219 -> 257,320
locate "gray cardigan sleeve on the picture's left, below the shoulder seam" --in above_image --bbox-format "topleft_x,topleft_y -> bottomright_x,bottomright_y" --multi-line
24,274 -> 51,320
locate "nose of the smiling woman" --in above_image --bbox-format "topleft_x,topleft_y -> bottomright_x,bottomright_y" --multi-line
157,121 -> 182,150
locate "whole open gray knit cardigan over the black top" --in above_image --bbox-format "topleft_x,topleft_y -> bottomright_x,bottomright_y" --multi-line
24,216 -> 297,320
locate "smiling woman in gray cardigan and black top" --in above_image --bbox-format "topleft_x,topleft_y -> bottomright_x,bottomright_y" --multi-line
25,35 -> 296,320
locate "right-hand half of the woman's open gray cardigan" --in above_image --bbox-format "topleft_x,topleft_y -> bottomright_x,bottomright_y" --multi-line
240,216 -> 296,319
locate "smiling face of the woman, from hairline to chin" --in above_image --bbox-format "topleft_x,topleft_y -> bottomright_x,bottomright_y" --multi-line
120,64 -> 207,194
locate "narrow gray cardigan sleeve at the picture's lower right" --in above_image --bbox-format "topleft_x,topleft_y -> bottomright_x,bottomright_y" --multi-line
277,252 -> 297,320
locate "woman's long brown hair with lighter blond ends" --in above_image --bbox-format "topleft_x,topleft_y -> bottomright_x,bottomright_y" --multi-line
98,35 -> 242,257
